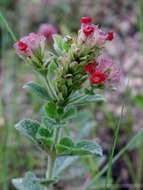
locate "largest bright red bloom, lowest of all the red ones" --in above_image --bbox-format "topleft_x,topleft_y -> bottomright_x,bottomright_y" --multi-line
90,71 -> 107,84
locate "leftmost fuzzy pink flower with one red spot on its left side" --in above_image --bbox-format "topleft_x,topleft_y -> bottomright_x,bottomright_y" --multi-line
14,33 -> 45,57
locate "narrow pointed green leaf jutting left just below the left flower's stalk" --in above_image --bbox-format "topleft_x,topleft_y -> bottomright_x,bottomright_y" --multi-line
23,82 -> 51,101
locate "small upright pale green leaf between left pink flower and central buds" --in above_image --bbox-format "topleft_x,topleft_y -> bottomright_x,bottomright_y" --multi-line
53,34 -> 63,55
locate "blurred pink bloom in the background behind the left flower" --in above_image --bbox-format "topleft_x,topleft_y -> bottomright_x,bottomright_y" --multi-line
38,24 -> 57,40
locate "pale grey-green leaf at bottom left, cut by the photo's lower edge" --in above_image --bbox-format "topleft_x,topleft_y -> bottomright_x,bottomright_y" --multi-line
12,172 -> 44,190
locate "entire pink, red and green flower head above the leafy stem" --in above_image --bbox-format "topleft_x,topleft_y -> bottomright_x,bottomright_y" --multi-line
15,17 -> 121,101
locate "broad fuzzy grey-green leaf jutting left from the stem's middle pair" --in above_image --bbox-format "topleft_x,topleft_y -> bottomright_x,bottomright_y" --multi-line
15,119 -> 40,141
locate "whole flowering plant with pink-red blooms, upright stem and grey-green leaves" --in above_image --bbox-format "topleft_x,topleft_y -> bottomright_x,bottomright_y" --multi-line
13,17 -> 121,190
